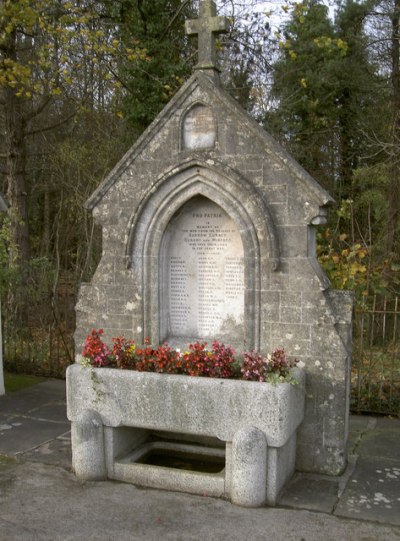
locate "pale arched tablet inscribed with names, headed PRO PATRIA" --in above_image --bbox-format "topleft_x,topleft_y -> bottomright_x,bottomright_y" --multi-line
162,197 -> 244,339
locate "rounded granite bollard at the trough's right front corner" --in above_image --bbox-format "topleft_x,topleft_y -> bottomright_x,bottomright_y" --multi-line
231,427 -> 267,507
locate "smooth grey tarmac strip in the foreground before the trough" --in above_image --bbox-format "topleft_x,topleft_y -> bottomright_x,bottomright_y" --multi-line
0,463 -> 400,541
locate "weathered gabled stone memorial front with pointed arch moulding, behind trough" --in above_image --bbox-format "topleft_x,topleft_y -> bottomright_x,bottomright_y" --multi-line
76,41 -> 352,474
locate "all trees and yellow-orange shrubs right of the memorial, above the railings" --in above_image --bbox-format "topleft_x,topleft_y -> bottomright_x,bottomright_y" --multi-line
265,0 -> 400,299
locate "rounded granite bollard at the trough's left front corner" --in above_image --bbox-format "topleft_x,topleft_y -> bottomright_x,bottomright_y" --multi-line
71,410 -> 107,481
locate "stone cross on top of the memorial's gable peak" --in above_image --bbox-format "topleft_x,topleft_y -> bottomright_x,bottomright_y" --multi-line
185,0 -> 228,69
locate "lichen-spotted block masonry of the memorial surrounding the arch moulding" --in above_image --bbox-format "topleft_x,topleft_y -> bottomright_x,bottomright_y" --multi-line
75,75 -> 352,474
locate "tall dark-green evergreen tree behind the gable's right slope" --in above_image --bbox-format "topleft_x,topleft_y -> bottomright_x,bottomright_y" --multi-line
266,0 -> 381,200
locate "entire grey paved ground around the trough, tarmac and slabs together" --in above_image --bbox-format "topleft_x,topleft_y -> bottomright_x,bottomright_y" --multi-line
0,380 -> 400,541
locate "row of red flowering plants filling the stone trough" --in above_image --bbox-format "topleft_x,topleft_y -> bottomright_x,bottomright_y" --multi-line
82,329 -> 299,383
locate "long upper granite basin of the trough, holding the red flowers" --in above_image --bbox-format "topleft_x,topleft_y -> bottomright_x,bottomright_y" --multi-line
67,365 -> 304,447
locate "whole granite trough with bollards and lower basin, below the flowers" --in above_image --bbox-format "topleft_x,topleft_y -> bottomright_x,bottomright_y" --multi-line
67,365 -> 305,507
